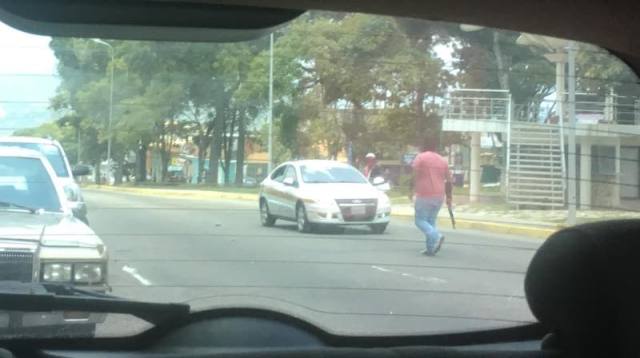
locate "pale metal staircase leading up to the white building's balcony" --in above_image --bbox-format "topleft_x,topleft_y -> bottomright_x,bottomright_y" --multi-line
507,121 -> 565,209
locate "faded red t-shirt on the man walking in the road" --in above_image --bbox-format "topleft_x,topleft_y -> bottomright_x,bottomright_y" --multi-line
412,152 -> 449,199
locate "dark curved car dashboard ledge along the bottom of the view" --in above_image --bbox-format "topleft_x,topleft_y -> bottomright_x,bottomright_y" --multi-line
0,309 -> 556,358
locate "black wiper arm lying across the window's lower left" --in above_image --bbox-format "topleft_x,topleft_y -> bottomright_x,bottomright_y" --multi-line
0,281 -> 190,325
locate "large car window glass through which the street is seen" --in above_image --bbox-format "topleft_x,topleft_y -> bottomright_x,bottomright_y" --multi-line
0,11 -> 640,335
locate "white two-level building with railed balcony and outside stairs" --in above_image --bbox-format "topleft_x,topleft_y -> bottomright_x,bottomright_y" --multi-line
443,90 -> 640,209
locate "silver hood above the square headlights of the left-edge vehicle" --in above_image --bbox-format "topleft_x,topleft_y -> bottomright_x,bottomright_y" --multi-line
0,210 -> 102,247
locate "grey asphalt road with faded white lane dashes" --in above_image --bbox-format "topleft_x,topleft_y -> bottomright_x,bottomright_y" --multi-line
85,190 -> 542,334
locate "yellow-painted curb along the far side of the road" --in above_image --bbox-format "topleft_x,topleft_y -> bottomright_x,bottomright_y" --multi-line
83,185 -> 562,239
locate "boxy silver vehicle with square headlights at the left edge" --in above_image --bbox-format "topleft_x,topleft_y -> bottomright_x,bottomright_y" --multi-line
0,146 -> 108,336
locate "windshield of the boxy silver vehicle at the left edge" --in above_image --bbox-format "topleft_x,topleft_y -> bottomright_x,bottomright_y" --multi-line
0,156 -> 61,213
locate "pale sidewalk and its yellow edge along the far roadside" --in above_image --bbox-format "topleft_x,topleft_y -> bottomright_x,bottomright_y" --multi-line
83,185 -> 592,238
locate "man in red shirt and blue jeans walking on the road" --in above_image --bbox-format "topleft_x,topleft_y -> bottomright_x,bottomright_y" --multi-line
412,138 -> 452,256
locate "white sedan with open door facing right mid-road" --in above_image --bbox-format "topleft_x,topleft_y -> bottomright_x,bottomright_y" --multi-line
260,160 -> 391,234
